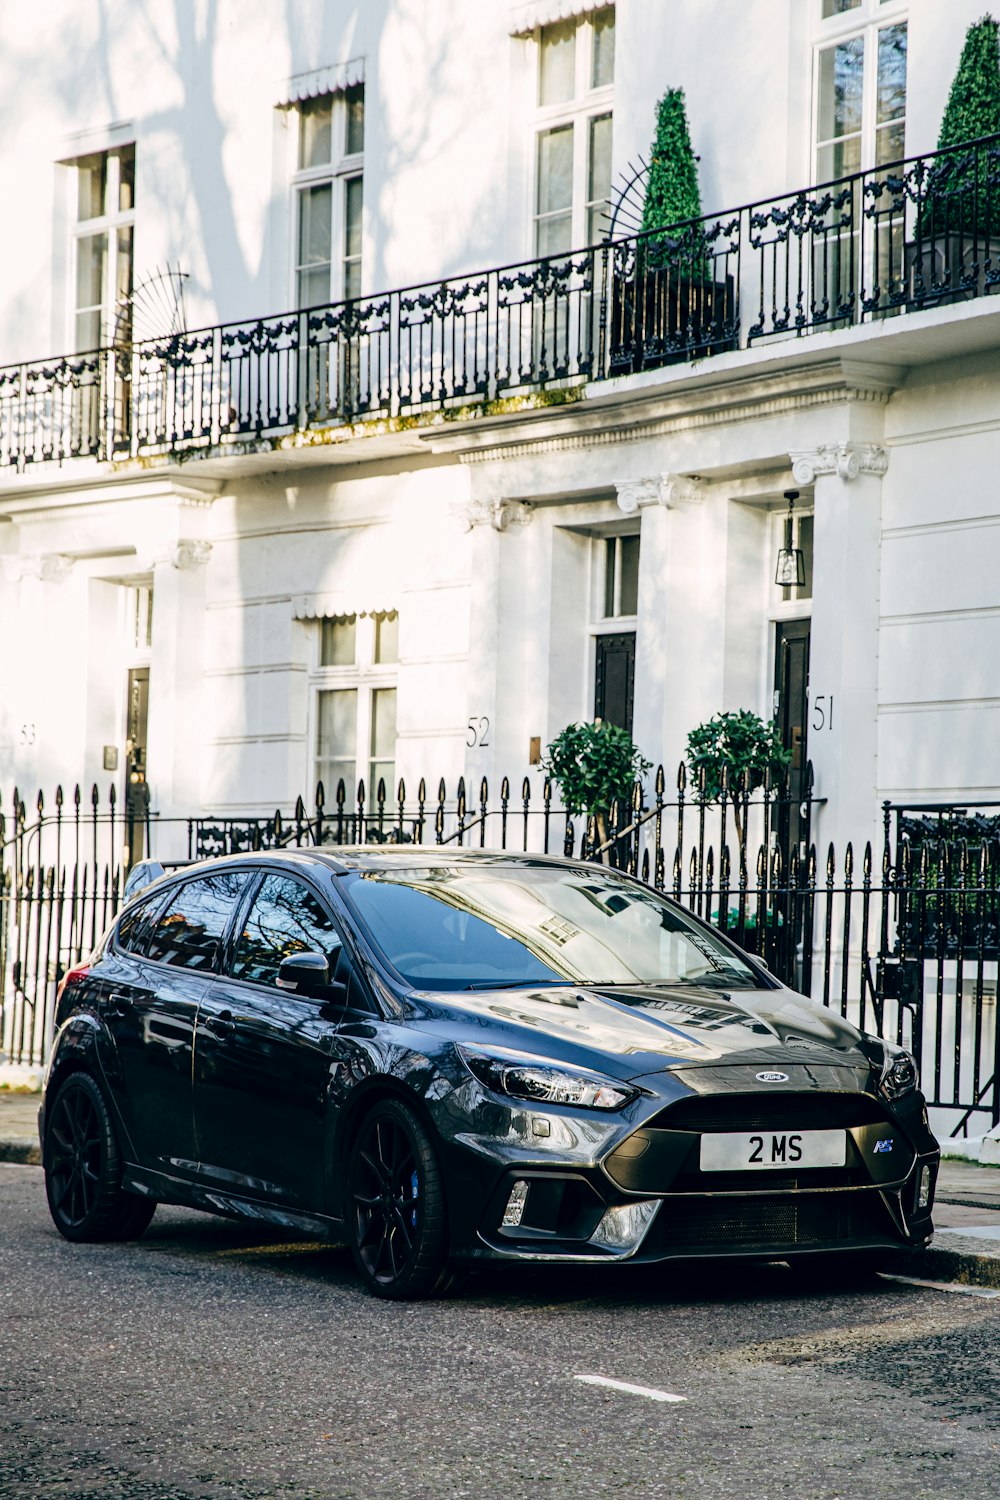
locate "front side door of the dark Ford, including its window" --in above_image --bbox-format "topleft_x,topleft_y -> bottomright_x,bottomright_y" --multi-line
193,872 -> 352,1212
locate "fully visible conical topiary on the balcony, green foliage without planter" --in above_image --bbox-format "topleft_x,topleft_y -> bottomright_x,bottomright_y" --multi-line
642,89 -> 706,276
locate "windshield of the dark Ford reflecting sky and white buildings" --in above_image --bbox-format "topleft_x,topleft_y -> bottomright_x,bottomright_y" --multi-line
345,861 -> 760,990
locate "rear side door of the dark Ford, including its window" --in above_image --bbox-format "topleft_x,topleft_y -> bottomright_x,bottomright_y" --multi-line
99,870 -> 249,1176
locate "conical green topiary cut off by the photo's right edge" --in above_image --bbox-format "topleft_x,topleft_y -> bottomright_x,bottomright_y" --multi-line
918,15 -> 1000,239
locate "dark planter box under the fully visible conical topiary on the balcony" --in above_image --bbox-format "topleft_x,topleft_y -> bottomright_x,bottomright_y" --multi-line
609,266 -> 739,375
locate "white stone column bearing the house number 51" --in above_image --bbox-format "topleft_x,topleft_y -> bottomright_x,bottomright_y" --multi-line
790,443 -> 889,852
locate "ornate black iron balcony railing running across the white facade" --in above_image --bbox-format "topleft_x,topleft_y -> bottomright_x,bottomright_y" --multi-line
0,137 -> 1000,471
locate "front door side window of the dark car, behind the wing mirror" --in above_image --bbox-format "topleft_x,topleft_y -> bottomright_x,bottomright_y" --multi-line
229,875 -> 342,984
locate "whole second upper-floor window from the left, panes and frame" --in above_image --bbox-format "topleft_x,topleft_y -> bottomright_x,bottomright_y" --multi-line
295,84 -> 364,308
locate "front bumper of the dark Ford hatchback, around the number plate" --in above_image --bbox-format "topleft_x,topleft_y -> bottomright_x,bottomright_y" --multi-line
443,1092 -> 940,1263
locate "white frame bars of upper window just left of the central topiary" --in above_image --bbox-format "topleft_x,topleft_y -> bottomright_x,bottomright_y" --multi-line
528,5 -> 618,260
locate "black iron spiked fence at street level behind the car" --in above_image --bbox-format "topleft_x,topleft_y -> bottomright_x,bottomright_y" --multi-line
0,767 -> 1000,1134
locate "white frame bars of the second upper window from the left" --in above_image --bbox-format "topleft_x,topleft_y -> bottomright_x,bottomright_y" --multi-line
289,83 -> 366,311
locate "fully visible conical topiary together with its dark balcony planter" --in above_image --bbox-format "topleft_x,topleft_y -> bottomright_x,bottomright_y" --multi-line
612,89 -> 735,371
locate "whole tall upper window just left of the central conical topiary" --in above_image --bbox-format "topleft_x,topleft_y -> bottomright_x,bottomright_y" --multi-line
534,8 -> 615,255
